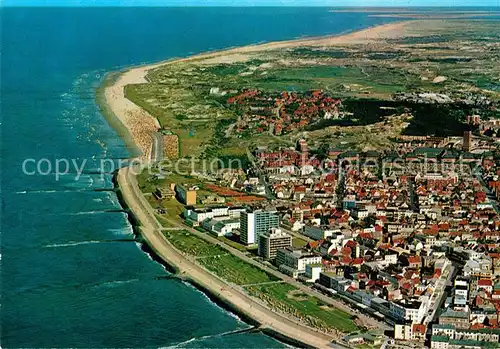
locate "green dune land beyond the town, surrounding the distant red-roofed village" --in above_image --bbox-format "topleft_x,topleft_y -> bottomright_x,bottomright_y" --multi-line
125,20 -> 500,158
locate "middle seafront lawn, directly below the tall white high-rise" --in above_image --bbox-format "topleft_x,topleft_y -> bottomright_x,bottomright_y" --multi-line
198,254 -> 278,285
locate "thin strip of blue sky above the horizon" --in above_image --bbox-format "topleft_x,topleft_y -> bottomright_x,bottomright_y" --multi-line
0,0 -> 500,7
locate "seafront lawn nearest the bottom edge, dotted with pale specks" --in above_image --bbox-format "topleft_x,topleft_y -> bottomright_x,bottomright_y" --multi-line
247,284 -> 359,333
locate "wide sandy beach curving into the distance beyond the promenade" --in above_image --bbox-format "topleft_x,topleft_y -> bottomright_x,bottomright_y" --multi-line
97,20 -> 414,162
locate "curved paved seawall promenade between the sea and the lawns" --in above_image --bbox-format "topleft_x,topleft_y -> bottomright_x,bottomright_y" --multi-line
116,167 -> 334,348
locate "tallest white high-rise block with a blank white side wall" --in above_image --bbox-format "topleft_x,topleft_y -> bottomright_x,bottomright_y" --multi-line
240,210 -> 279,245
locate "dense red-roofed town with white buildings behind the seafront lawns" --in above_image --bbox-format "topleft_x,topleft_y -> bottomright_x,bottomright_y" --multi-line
140,113 -> 500,349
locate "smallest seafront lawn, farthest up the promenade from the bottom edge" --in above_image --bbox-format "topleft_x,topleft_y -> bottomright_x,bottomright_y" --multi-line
165,230 -> 227,257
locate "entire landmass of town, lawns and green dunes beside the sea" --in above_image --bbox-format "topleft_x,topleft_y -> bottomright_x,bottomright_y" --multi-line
122,21 -> 500,349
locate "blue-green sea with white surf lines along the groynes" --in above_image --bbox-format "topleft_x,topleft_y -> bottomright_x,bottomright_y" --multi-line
0,7 -> 496,348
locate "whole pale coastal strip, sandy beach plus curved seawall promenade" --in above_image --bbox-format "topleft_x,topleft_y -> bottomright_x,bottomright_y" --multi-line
98,21 -> 415,348
